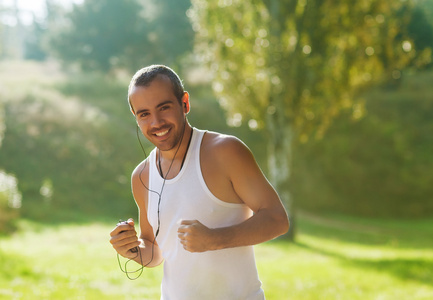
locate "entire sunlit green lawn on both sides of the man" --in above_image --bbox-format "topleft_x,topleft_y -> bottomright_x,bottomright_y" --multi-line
0,214 -> 433,300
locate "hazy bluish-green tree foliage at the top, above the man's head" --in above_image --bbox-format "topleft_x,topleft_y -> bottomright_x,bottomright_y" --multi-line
46,0 -> 193,71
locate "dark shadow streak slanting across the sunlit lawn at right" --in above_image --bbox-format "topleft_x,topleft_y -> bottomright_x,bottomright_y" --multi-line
295,242 -> 433,286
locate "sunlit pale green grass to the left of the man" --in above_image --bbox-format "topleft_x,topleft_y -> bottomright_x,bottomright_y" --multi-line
0,223 -> 162,299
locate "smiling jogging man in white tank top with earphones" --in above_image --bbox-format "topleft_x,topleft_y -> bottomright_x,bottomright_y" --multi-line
110,65 -> 289,300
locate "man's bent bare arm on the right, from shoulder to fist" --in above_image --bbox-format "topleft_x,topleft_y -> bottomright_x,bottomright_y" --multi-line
178,138 -> 289,252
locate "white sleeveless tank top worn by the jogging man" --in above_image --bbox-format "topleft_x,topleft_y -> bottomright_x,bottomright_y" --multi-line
147,128 -> 265,300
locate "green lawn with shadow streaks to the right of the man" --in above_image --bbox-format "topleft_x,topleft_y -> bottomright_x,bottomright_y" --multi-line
262,214 -> 433,299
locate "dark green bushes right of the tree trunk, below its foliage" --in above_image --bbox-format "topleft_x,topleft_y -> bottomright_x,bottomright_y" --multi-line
292,72 -> 433,217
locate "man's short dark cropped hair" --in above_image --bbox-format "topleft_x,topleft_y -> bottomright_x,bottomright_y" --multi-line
128,65 -> 185,109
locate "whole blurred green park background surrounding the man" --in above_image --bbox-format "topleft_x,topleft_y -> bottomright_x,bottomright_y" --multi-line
0,0 -> 433,299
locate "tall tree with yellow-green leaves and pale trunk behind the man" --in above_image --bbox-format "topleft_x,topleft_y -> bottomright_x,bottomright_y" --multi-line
189,0 -> 428,238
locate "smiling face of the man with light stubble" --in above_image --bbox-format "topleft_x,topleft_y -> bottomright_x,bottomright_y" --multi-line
129,78 -> 187,151
